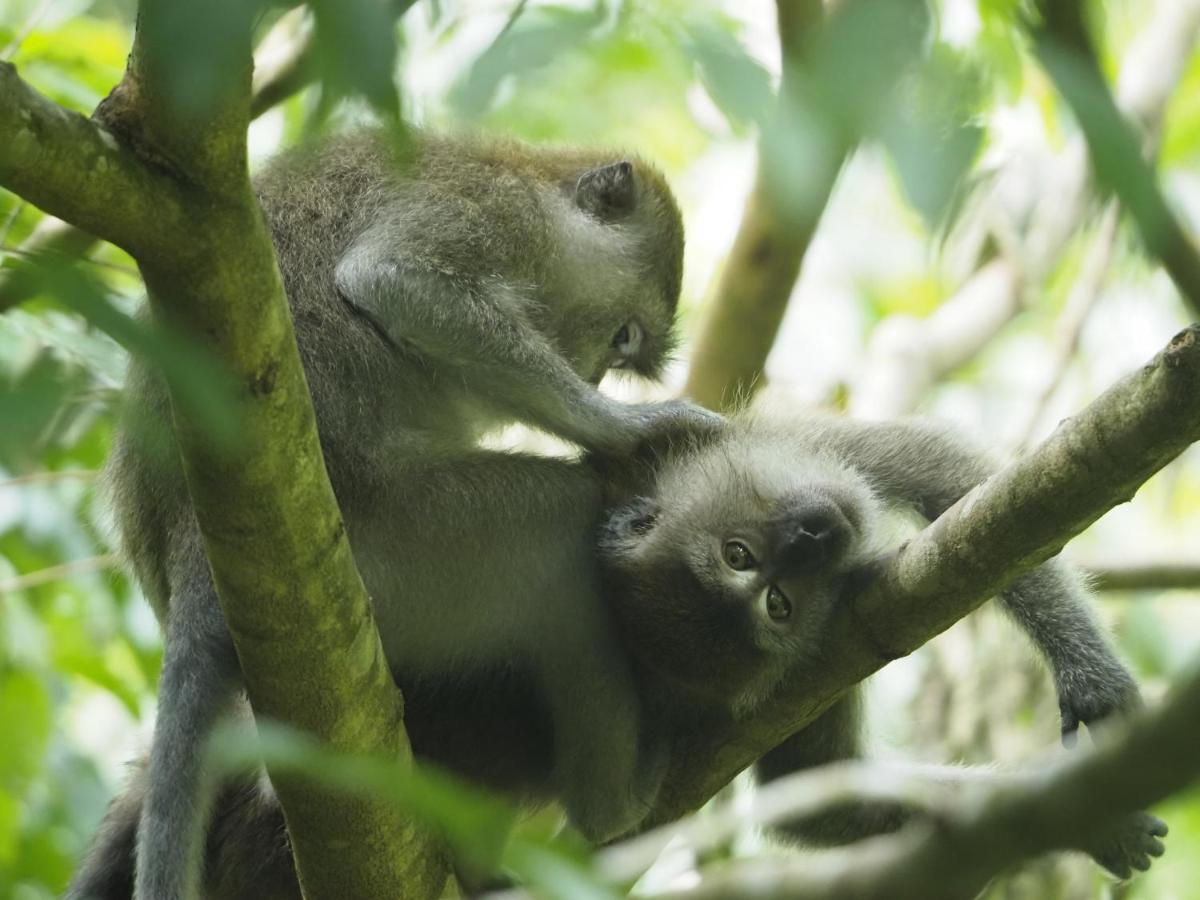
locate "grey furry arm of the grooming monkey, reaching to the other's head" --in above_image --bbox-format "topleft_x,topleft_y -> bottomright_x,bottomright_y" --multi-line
335,236 -> 714,450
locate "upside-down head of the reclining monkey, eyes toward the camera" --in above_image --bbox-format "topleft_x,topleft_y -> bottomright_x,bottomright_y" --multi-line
600,420 -> 878,713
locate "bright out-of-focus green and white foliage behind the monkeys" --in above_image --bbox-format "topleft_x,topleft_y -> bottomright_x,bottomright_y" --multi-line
0,0 -> 1200,900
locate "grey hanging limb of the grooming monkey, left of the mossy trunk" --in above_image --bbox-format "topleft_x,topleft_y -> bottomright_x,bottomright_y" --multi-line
134,542 -> 240,900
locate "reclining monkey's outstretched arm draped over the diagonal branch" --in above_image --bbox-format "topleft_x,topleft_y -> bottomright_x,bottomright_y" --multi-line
804,419 -> 1140,738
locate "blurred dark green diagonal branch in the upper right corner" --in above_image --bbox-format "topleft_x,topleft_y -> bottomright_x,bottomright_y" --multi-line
1032,0 -> 1200,318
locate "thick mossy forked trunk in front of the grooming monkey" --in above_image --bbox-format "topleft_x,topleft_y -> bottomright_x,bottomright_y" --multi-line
0,0 -> 445,898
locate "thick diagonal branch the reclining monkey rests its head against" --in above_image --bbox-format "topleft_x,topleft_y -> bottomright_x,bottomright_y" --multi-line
649,328 -> 1200,824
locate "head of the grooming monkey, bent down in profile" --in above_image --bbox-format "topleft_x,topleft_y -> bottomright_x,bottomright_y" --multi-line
554,157 -> 683,383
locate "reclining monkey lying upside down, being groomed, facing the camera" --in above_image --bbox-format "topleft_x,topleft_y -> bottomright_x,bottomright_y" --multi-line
70,414 -> 1165,900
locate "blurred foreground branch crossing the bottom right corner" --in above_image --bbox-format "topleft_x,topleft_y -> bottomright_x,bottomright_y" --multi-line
656,668 -> 1200,900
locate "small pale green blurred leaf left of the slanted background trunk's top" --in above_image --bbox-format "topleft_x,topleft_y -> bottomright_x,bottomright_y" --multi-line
685,22 -> 774,126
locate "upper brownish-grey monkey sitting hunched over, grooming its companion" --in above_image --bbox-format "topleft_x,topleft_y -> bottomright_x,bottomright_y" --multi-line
106,130 -> 715,900
